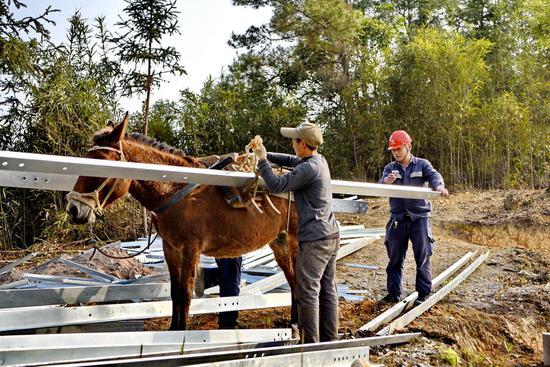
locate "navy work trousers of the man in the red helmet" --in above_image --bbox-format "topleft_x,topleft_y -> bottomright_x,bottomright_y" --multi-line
385,216 -> 435,296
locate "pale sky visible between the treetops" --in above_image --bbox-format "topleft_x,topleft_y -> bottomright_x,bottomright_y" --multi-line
15,0 -> 272,110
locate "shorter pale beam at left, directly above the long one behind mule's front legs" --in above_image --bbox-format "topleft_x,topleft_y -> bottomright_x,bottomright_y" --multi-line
0,283 -> 170,309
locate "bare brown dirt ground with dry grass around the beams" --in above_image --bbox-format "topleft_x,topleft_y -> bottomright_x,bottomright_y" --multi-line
0,190 -> 550,366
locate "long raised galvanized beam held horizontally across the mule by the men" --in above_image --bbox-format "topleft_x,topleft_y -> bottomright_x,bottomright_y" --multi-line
0,151 -> 440,199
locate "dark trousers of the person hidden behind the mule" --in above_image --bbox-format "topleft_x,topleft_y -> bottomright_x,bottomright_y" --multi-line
216,257 -> 243,329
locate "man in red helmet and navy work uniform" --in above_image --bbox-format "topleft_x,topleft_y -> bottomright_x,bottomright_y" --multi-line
380,130 -> 449,304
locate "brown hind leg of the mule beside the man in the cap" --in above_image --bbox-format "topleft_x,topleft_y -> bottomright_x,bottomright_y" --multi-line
269,231 -> 298,324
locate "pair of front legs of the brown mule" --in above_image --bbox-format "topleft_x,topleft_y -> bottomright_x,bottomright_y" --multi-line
164,243 -> 200,330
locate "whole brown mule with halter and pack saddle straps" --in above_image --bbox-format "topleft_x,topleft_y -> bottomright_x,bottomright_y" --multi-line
67,114 -> 298,330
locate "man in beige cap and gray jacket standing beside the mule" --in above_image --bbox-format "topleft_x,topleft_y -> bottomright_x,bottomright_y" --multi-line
254,123 -> 340,343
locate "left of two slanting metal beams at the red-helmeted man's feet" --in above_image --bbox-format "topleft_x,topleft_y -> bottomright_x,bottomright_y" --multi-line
358,252 -> 475,331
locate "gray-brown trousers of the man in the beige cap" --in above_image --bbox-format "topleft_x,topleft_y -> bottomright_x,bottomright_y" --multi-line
296,238 -> 340,343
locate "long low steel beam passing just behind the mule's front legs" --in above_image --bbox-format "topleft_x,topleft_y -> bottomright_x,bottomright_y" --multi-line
0,293 -> 291,331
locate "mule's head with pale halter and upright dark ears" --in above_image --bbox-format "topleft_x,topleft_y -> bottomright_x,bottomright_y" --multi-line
66,113 -> 131,224
